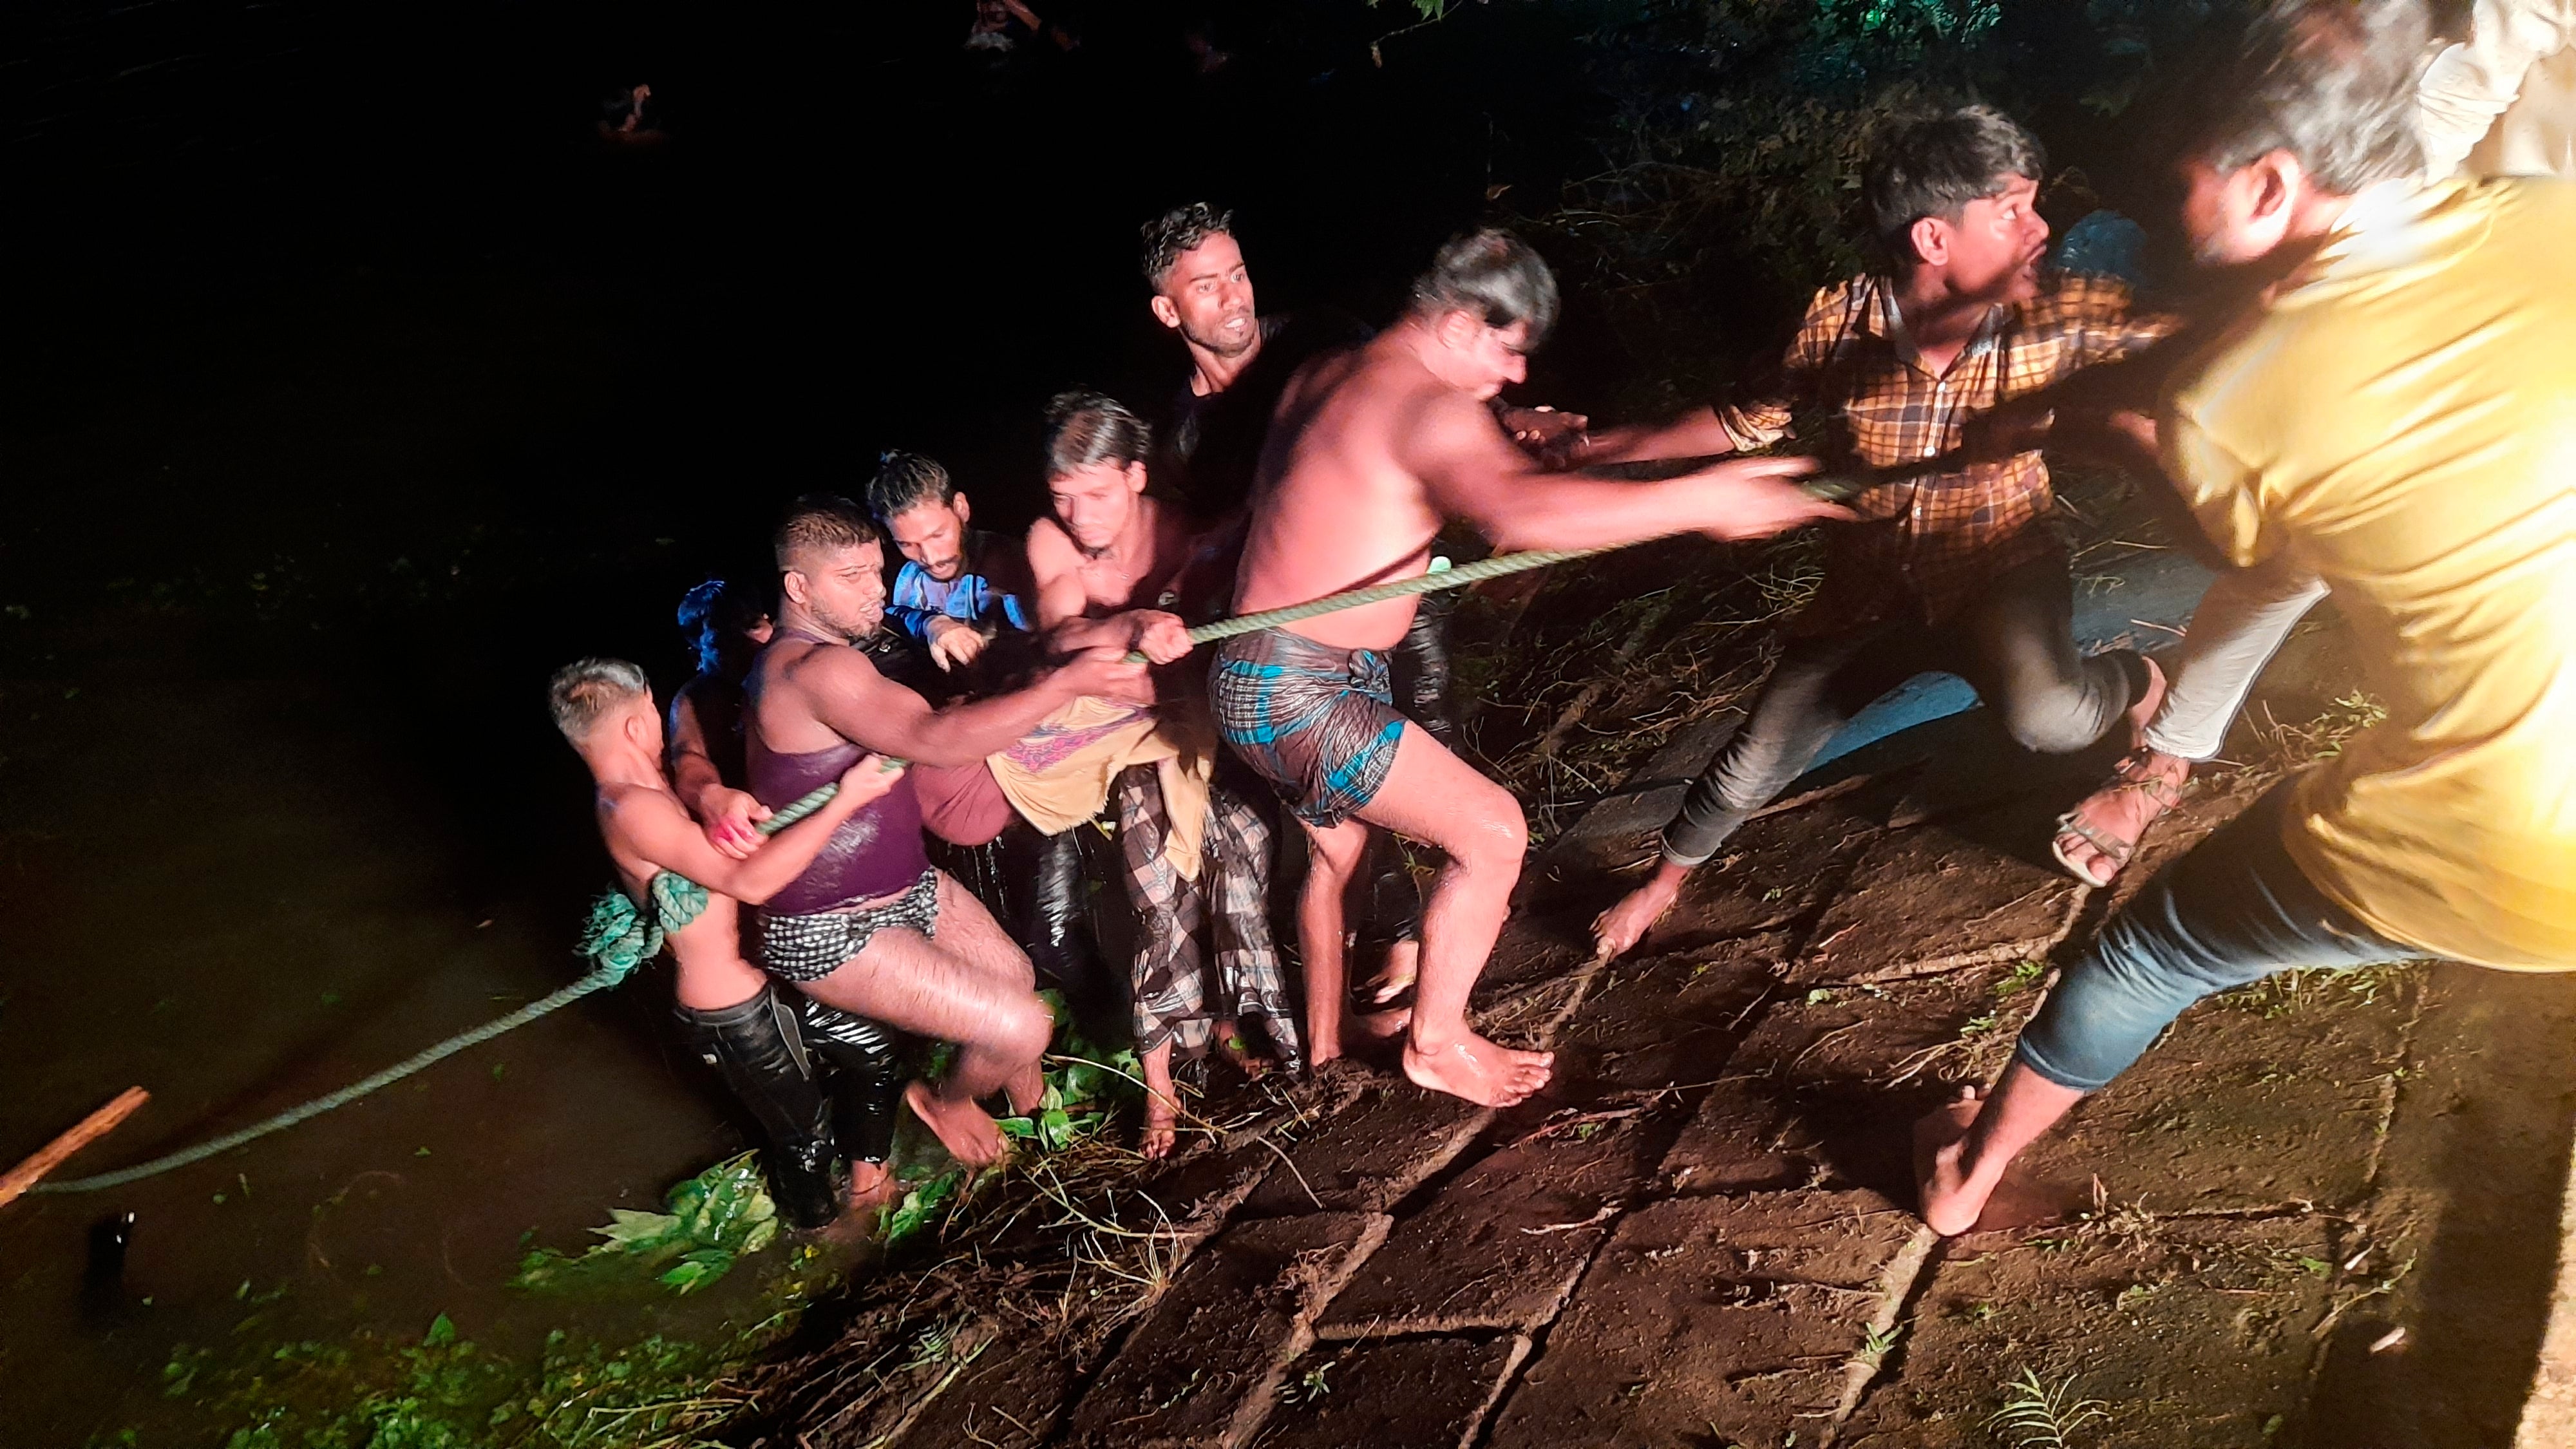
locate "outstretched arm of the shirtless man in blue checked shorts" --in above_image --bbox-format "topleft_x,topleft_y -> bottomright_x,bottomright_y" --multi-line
1396,395 -> 1850,549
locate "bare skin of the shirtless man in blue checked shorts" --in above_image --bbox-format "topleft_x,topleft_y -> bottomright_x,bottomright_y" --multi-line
1234,312 -> 1842,1106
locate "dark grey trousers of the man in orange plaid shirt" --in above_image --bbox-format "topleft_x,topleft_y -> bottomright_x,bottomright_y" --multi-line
1664,554 -> 2146,866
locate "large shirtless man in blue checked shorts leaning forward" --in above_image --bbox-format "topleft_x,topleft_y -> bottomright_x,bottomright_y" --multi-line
1211,232 -> 1847,1106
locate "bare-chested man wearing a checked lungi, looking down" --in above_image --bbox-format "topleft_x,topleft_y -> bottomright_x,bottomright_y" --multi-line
1028,392 -> 1298,1158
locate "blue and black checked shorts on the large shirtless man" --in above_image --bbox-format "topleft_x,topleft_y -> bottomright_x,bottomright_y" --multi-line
1208,629 -> 1404,825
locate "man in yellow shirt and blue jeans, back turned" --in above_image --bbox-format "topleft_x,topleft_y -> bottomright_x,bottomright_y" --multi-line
1917,0 -> 2576,1233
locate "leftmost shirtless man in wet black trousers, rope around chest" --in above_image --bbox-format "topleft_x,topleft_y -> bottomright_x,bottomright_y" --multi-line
549,660 -> 896,1227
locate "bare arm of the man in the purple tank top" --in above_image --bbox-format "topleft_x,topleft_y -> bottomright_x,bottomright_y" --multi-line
791,634 -> 1144,766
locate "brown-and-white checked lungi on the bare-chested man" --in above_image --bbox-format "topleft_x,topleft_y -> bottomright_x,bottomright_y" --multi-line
1113,766 -> 1303,1072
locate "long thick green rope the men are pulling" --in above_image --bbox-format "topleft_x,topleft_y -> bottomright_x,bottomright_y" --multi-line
28,489 -> 1855,1194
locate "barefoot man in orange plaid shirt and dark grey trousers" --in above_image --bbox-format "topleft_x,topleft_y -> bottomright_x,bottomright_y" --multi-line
1584,106 -> 2174,956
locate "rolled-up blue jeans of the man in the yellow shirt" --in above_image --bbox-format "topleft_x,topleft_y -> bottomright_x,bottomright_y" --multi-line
2014,781 -> 2424,1091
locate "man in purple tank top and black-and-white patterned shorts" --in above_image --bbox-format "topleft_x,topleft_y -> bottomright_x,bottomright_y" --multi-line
744,498 -> 1144,1166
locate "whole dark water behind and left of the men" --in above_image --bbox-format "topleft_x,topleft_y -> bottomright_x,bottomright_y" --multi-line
0,0 -> 1600,1446
